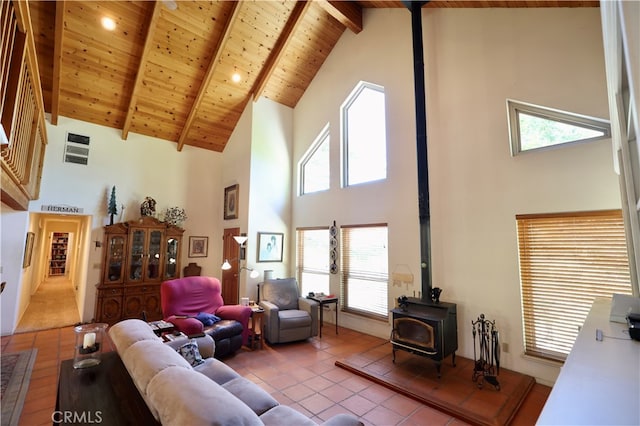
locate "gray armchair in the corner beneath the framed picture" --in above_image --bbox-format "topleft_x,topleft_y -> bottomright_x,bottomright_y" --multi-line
258,278 -> 319,343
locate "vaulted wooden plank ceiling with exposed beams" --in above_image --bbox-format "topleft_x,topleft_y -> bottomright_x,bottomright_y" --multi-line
29,0 -> 599,152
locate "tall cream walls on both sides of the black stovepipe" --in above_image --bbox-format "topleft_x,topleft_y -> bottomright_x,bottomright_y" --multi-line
292,8 -> 620,384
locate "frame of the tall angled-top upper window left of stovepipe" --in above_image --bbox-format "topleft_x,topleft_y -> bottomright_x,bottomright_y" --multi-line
340,81 -> 389,188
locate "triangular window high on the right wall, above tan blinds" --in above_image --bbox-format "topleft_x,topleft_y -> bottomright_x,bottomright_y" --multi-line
507,100 -> 611,155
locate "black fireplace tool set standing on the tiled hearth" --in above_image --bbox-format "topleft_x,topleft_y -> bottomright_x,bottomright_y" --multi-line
471,314 -> 500,390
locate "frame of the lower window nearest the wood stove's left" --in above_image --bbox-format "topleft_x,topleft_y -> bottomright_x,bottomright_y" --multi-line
340,223 -> 390,321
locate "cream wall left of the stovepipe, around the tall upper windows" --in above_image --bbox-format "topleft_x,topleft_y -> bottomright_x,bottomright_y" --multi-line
291,9 -> 421,338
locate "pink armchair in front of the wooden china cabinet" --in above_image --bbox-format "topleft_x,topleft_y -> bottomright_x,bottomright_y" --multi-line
160,276 -> 251,358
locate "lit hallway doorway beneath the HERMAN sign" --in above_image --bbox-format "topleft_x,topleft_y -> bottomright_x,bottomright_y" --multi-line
16,213 -> 91,333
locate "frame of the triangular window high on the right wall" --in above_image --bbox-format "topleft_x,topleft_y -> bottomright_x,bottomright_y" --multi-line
507,99 -> 611,157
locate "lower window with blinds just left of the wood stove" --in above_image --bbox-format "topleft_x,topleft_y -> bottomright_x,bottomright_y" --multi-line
340,224 -> 389,319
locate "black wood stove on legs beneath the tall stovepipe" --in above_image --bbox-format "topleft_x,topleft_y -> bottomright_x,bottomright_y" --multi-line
391,298 -> 458,377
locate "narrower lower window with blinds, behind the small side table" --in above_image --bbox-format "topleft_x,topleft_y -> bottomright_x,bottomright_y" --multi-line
296,227 -> 331,295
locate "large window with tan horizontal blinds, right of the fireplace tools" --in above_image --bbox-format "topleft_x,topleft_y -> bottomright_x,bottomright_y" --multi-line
516,210 -> 631,361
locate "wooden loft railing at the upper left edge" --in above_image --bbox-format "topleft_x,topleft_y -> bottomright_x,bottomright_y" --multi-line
0,1 -> 47,210
